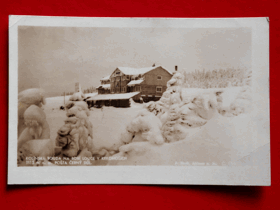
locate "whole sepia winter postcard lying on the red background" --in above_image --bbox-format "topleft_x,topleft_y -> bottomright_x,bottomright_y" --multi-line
8,16 -> 270,185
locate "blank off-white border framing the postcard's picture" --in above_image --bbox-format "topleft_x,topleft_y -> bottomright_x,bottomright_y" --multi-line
8,16 -> 271,185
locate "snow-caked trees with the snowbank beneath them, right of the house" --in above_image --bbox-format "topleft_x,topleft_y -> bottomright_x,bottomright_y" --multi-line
110,69 -> 257,165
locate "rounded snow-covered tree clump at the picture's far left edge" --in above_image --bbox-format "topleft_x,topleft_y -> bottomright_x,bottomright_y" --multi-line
18,88 -> 50,166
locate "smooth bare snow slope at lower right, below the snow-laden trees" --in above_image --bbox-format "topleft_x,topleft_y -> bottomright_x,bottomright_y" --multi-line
109,104 -> 269,165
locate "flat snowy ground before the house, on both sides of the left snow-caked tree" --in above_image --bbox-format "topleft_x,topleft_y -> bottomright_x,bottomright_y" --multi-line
43,94 -> 143,156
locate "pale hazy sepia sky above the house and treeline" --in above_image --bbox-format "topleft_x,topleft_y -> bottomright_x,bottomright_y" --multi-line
18,26 -> 252,97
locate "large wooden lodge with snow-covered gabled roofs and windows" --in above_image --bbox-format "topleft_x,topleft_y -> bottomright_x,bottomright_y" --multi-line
93,66 -> 173,106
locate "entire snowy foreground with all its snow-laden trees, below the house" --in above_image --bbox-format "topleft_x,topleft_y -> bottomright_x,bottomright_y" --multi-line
18,72 -> 269,166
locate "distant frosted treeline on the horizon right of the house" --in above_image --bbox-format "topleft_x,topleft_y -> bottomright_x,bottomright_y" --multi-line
183,68 -> 251,88
